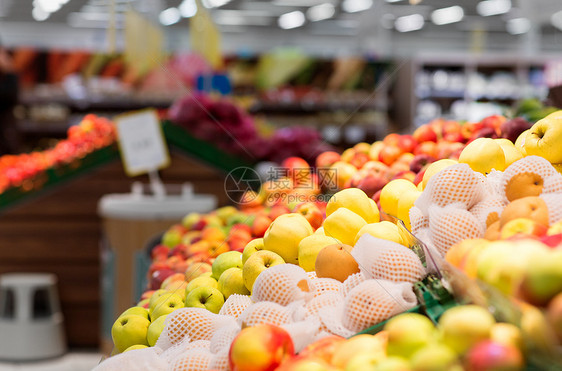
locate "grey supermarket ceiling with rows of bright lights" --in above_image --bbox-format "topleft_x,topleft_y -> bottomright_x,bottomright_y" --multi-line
0,0 -> 562,35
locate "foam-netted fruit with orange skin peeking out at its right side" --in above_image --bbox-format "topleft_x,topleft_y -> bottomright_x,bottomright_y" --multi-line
252,264 -> 312,305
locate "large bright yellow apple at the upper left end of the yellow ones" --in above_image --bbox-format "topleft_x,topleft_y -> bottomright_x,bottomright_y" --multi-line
263,213 -> 314,264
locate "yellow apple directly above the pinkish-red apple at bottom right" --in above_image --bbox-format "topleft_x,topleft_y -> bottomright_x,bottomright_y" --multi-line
439,305 -> 496,354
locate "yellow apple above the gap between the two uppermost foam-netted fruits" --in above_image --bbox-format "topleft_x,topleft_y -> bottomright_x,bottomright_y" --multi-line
459,138 -> 506,174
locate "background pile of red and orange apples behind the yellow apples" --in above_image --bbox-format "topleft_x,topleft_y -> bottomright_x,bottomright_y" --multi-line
316,116 -> 531,201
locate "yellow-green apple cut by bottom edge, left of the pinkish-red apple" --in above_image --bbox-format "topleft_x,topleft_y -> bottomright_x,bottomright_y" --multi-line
410,344 -> 463,371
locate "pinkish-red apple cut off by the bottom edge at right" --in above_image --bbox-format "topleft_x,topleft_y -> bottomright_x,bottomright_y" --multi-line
465,341 -> 525,371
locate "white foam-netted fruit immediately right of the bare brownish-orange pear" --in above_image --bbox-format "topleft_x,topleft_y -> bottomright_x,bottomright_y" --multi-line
351,234 -> 426,283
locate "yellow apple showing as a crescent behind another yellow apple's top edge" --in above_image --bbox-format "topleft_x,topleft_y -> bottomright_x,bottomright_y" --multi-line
326,188 -> 379,223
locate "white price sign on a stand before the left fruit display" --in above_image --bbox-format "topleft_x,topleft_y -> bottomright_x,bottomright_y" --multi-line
115,109 -> 170,176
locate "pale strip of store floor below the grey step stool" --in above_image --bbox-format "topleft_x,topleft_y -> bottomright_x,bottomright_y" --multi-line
0,352 -> 102,371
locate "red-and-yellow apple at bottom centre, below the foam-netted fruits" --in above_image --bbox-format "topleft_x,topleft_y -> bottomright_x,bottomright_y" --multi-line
228,324 -> 295,371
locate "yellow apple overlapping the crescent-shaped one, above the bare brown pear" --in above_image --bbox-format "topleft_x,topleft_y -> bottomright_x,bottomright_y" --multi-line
324,207 -> 367,246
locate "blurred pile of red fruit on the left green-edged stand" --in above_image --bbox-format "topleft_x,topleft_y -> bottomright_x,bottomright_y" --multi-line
0,114 -> 116,194
